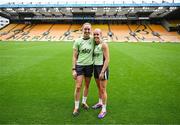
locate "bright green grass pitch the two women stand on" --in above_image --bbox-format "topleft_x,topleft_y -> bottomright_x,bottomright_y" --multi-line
0,41 -> 180,124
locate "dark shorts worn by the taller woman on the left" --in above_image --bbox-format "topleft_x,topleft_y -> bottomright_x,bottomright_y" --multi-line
76,65 -> 93,77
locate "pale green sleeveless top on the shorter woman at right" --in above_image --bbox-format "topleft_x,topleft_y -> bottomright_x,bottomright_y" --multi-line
94,44 -> 104,65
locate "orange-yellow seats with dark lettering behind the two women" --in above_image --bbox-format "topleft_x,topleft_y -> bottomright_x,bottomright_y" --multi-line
0,24 -> 180,42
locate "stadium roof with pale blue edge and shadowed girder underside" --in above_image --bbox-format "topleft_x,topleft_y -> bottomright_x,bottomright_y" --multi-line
0,0 -> 180,20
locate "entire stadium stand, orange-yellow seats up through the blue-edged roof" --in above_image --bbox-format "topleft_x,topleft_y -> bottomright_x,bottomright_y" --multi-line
0,2 -> 180,42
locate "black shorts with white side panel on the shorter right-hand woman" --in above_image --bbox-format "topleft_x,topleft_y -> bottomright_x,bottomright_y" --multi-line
94,65 -> 109,80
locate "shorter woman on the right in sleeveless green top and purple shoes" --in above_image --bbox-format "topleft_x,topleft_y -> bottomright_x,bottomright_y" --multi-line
92,29 -> 109,119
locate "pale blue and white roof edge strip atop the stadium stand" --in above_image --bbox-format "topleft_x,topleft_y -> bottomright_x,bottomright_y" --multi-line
0,0 -> 180,8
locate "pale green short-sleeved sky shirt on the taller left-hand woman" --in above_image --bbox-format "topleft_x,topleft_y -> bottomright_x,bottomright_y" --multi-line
73,37 -> 94,65
